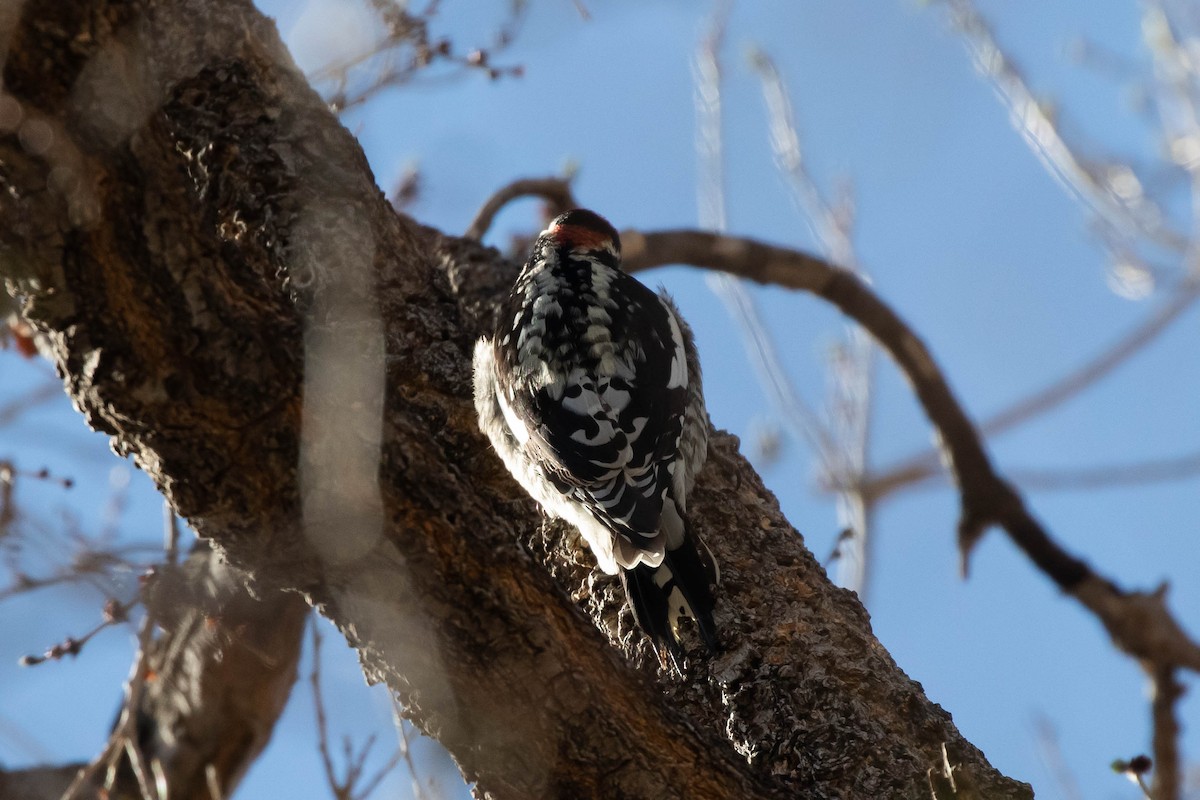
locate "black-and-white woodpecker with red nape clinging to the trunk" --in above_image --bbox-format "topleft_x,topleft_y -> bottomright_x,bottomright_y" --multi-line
474,209 -> 719,669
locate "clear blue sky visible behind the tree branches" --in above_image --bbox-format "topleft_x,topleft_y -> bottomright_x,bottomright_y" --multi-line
0,0 -> 1200,800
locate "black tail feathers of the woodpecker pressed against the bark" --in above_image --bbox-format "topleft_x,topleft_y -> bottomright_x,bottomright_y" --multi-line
620,534 -> 719,668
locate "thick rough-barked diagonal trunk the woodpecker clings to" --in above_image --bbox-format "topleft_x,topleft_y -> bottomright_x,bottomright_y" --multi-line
0,0 -> 1031,798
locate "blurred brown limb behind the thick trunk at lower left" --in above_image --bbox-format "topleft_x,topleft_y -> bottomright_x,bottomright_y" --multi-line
0,543 -> 308,800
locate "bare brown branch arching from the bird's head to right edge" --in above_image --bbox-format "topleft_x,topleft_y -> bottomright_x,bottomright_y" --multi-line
622,230 -> 1200,672
